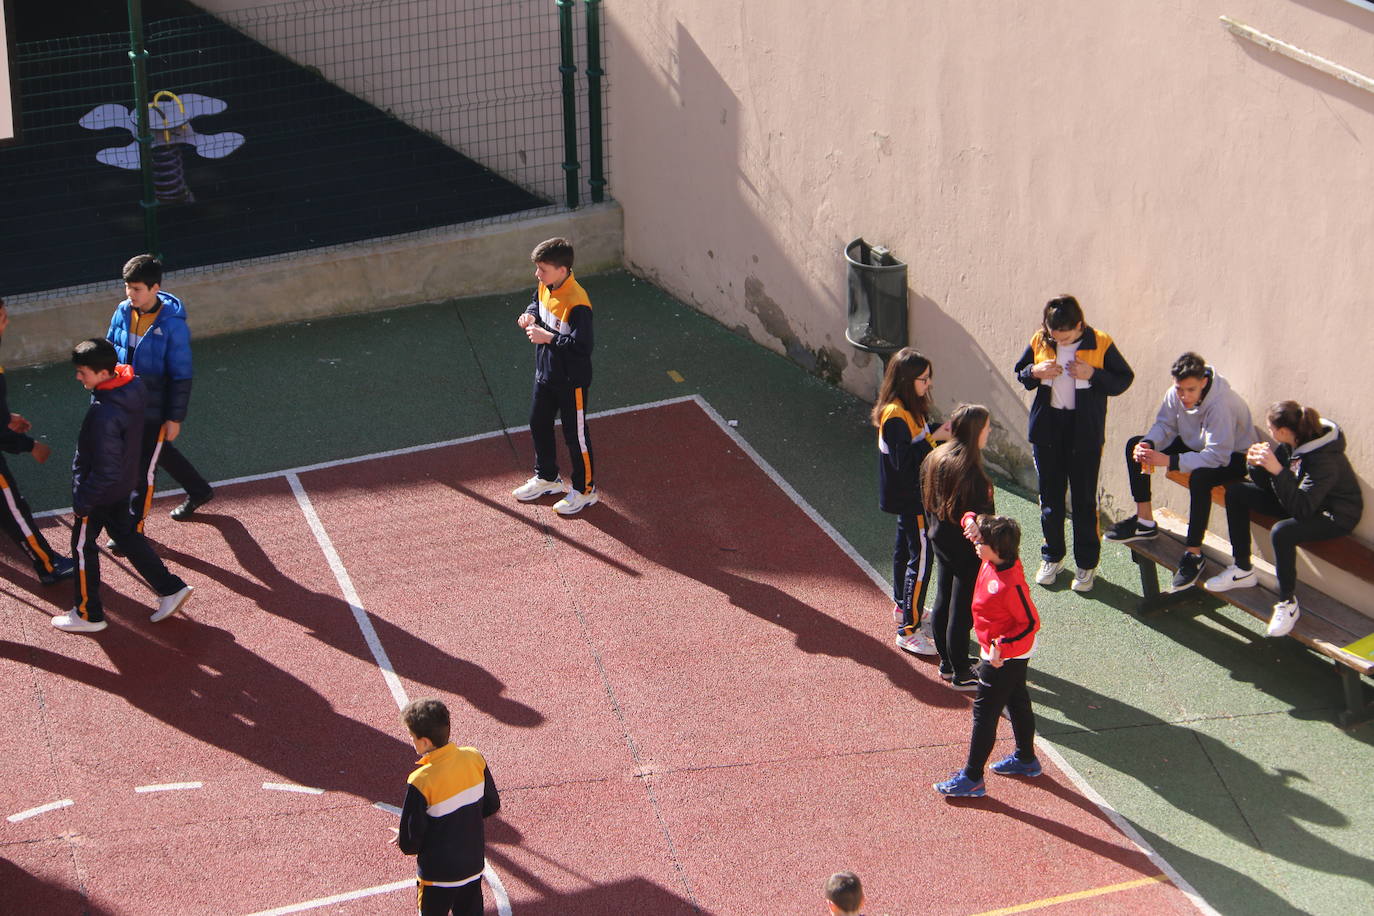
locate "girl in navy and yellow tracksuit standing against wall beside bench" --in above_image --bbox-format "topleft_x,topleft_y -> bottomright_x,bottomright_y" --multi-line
1013,295 -> 1135,592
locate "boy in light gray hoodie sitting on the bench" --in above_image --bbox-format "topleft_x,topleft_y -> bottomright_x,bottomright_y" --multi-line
1106,353 -> 1254,592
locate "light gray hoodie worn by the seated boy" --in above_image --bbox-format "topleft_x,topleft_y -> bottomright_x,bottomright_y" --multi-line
1145,365 -> 1256,472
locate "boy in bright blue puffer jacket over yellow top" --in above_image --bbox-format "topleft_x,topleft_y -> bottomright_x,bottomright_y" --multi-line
104,254 -> 214,538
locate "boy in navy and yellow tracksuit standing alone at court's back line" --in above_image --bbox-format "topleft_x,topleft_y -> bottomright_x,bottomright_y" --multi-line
511,239 -> 598,515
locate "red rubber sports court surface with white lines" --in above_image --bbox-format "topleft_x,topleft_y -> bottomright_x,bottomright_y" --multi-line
0,400 -> 1195,916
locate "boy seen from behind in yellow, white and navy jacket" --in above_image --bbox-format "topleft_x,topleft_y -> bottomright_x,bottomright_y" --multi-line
392,699 -> 502,916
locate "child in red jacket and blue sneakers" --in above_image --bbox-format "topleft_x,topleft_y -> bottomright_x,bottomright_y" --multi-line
934,512 -> 1040,798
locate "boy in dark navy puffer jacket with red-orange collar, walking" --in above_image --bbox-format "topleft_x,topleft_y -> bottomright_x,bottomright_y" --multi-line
52,338 -> 191,633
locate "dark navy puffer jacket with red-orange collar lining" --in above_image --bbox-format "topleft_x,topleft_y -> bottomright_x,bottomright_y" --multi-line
71,365 -> 148,515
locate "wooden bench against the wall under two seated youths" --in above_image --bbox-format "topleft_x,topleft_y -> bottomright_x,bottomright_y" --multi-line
1127,471 -> 1374,726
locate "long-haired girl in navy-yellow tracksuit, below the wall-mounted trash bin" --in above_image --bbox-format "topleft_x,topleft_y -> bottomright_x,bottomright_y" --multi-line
871,347 -> 949,655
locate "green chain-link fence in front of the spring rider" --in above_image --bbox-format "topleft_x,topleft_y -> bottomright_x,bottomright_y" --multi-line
0,0 -> 609,294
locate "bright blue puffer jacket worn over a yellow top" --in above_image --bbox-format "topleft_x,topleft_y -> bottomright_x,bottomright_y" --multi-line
104,291 -> 191,423
